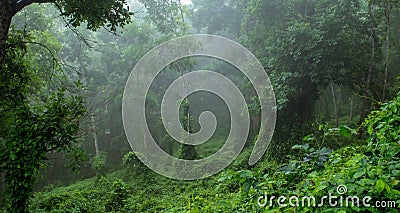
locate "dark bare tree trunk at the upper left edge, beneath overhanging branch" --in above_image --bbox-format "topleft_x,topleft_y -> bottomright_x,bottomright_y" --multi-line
0,0 -> 12,72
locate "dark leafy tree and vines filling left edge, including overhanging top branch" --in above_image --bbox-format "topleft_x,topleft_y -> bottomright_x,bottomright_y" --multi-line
0,1 -> 131,212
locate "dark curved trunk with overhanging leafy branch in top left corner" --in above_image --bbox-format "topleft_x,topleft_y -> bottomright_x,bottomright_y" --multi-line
0,0 -> 133,70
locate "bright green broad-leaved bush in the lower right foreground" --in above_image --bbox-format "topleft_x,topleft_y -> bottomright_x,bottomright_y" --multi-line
243,94 -> 400,212
